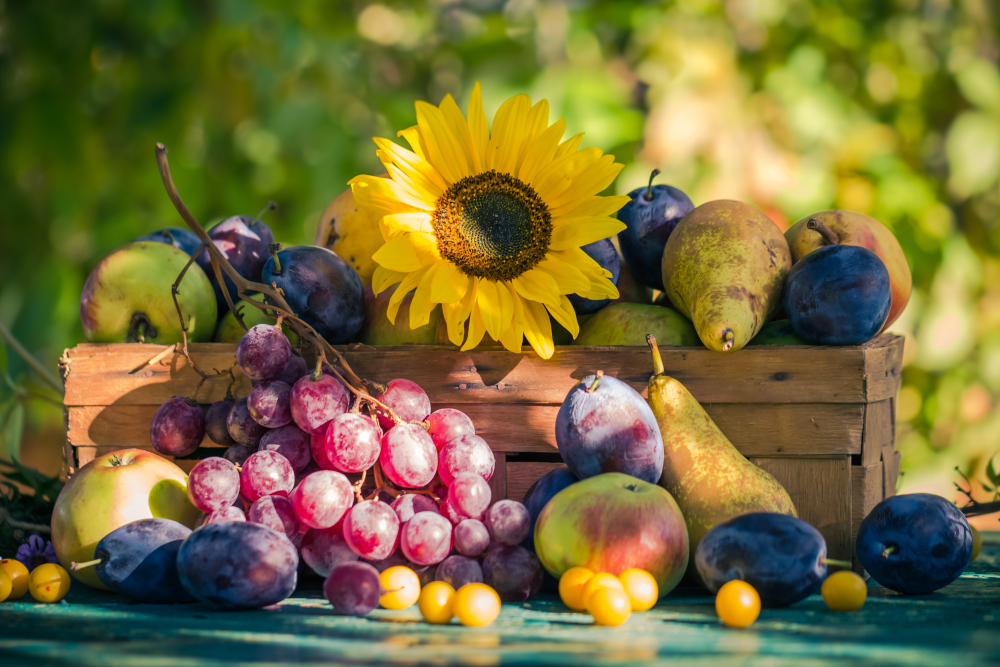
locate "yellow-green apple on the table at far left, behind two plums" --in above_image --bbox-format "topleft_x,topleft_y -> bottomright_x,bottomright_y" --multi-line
52,448 -> 191,590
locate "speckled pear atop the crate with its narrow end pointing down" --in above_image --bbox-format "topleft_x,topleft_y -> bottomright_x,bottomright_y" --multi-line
662,199 -> 792,352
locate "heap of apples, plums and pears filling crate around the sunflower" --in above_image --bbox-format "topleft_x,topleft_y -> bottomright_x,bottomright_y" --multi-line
80,172 -> 911,351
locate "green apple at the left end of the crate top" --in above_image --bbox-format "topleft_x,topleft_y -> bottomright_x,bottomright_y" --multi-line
80,241 -> 217,345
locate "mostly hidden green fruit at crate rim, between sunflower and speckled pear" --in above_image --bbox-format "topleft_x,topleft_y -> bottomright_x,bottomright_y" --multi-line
573,303 -> 701,347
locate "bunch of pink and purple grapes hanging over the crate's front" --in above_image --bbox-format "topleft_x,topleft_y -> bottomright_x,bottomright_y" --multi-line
150,324 -> 544,609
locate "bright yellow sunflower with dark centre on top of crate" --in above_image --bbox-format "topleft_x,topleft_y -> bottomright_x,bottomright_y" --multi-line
350,83 -> 629,359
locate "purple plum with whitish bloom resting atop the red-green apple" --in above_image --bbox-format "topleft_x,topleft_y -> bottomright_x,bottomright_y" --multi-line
556,371 -> 663,484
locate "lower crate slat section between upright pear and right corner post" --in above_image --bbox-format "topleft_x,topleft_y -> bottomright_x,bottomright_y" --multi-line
750,456 -> 853,560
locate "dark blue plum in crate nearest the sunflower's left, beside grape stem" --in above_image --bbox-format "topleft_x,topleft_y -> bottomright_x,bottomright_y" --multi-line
262,246 -> 365,344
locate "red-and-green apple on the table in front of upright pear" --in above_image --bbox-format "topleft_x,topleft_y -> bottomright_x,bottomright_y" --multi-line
535,472 -> 689,597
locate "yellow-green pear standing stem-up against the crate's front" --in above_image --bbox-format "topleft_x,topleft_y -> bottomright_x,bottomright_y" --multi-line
647,336 -> 797,576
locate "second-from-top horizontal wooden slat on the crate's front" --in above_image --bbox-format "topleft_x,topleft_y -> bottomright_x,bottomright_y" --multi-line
66,403 -> 864,458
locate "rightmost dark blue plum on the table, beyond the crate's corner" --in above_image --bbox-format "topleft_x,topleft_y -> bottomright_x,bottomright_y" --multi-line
857,493 -> 972,595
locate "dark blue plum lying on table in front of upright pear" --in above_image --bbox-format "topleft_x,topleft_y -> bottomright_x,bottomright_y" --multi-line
694,512 -> 826,608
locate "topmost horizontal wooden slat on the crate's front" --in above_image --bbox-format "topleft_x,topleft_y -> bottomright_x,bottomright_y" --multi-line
63,336 -> 901,405
